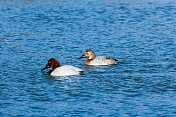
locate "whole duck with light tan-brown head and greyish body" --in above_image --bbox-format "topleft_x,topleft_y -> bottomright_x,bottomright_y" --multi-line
78,49 -> 118,66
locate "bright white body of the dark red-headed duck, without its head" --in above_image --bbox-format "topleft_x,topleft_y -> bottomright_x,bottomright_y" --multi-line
50,65 -> 84,76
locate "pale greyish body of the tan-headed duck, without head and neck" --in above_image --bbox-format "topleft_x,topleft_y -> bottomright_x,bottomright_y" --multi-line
88,56 -> 118,65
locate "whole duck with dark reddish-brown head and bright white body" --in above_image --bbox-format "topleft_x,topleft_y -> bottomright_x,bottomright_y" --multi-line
42,58 -> 85,76
